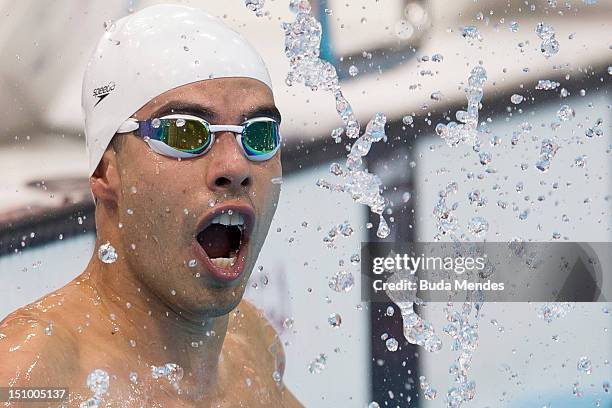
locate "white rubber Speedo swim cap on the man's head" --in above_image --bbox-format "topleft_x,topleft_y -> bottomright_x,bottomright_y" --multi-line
81,4 -> 272,176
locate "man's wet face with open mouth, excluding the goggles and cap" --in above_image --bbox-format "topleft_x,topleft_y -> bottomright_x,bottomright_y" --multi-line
109,78 -> 282,315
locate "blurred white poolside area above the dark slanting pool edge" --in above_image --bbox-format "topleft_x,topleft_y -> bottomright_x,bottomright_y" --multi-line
0,0 -> 612,213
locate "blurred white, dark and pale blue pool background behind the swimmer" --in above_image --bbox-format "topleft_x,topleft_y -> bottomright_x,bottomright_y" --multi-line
0,0 -> 612,408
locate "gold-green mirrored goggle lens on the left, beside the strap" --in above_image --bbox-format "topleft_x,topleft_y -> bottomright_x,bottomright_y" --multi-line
151,119 -> 211,154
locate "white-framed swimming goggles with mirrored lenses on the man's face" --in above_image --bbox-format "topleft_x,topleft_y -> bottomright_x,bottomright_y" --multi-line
117,114 -> 281,161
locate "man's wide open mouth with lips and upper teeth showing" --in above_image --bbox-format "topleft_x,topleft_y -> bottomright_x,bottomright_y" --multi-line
196,206 -> 254,280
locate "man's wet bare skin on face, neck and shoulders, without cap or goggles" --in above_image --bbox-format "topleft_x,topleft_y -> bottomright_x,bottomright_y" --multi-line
0,78 -> 302,407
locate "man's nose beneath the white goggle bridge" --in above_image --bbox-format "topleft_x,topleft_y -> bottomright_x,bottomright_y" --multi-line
206,132 -> 252,192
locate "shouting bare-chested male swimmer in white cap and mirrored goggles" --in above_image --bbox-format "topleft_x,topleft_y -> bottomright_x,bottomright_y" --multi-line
0,5 -> 302,407
